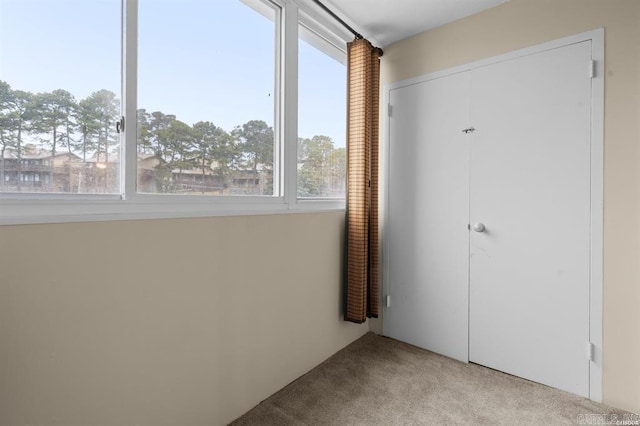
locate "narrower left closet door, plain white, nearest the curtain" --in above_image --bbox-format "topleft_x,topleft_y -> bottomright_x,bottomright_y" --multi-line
383,72 -> 469,361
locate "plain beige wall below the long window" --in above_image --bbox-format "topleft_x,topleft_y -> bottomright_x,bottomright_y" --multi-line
0,212 -> 368,426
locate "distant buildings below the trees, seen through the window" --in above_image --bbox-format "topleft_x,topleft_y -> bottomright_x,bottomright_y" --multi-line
0,145 -> 273,195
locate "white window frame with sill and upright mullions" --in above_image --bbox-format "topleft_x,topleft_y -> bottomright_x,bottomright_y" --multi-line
0,0 -> 352,225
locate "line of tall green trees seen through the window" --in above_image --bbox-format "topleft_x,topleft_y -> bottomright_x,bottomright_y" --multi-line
0,81 -> 346,196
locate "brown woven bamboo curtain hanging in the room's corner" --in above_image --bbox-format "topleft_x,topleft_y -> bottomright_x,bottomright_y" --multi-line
345,39 -> 380,323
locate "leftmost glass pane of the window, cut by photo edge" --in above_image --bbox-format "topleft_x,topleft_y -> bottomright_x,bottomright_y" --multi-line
0,0 -> 121,194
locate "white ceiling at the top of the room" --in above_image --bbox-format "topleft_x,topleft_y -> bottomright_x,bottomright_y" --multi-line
321,0 -> 508,47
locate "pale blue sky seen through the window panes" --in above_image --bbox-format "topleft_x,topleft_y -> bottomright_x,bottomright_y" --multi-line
0,0 -> 346,146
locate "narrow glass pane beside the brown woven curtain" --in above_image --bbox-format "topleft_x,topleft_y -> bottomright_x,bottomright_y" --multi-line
298,26 -> 347,198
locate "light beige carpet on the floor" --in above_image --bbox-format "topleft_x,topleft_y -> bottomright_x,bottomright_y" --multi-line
231,333 -> 628,426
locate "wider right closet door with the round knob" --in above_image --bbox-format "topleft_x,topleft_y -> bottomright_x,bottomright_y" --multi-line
469,42 -> 591,396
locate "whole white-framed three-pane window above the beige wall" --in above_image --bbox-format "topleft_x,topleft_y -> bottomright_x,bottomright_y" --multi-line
0,0 -> 351,224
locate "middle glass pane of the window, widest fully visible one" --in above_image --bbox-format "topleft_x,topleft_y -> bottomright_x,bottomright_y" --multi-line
137,0 -> 279,195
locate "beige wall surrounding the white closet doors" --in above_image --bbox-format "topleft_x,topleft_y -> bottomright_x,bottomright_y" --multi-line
372,0 -> 640,412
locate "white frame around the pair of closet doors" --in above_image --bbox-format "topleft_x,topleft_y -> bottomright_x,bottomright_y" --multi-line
380,28 -> 605,402
